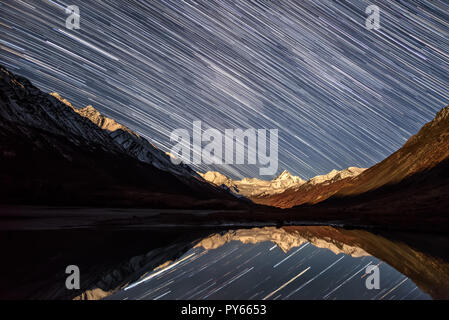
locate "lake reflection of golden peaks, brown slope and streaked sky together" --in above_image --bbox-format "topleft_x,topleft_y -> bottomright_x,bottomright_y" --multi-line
108,227 -> 448,300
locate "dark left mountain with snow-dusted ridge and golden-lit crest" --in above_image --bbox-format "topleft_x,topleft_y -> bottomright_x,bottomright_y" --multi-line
0,67 -> 247,208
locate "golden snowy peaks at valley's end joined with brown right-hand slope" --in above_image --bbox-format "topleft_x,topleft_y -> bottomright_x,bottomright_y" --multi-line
201,106 -> 449,218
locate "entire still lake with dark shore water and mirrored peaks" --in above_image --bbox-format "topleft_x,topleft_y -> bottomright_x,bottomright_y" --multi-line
0,207 -> 449,300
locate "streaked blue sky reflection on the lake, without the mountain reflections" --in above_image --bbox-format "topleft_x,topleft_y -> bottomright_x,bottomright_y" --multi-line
106,230 -> 431,300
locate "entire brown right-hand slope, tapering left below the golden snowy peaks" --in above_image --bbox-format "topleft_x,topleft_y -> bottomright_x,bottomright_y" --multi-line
240,102 -> 449,220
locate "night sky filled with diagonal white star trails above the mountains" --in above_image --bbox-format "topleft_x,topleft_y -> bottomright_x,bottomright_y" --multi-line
0,0 -> 449,179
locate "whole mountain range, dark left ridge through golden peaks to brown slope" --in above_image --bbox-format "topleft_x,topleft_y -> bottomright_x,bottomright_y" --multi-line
0,67 -> 449,229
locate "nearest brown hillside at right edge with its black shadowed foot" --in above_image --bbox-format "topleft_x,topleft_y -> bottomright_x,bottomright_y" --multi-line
289,106 -> 449,232
